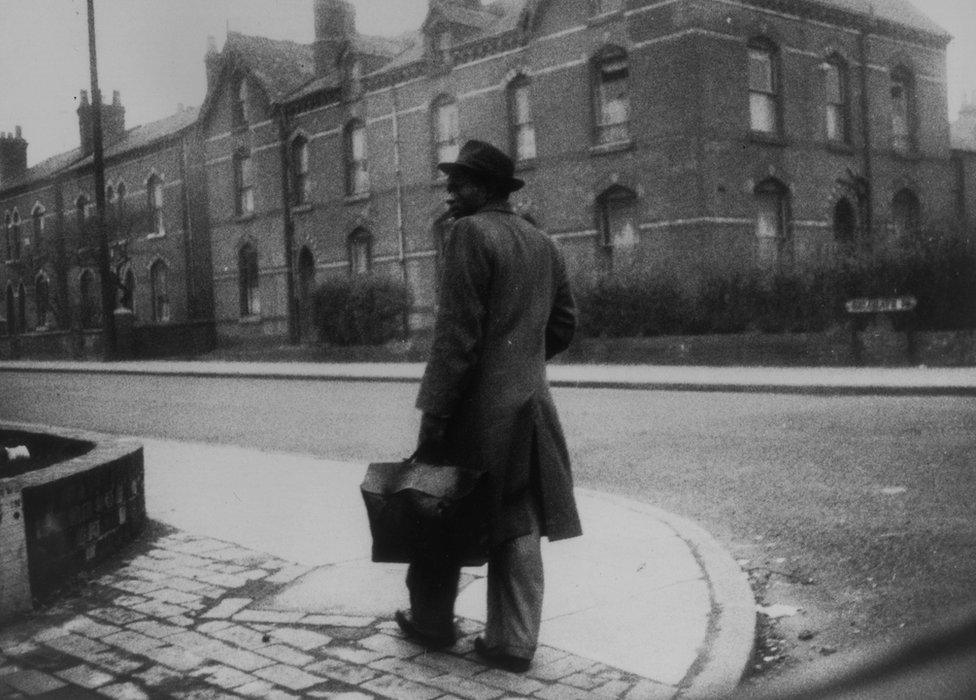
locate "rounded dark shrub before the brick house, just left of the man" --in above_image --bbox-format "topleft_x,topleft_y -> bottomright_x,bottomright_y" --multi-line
315,275 -> 411,345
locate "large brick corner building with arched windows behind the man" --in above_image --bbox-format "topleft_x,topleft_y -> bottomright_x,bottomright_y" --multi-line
4,0 -> 974,352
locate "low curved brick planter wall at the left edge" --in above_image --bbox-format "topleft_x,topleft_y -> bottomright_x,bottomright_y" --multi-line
0,424 -> 146,619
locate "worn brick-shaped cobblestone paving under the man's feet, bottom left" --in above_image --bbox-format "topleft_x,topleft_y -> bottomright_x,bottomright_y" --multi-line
0,526 -> 678,700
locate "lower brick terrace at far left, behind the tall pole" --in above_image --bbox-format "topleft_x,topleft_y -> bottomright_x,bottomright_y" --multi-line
0,91 -> 213,356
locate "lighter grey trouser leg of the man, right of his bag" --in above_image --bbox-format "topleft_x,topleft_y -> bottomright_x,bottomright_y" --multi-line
485,504 -> 544,659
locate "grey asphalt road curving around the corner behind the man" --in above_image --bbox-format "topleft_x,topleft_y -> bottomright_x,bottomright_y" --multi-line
0,372 -> 976,684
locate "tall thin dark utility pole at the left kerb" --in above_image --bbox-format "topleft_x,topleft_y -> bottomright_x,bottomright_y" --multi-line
88,0 -> 116,361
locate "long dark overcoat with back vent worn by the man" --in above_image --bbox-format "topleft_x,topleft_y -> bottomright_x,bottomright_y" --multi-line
417,203 -> 582,544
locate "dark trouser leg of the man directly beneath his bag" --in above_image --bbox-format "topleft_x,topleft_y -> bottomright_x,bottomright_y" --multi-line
407,554 -> 461,635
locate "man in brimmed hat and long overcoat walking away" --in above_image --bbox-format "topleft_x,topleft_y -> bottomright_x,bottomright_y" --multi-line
396,141 -> 582,672
